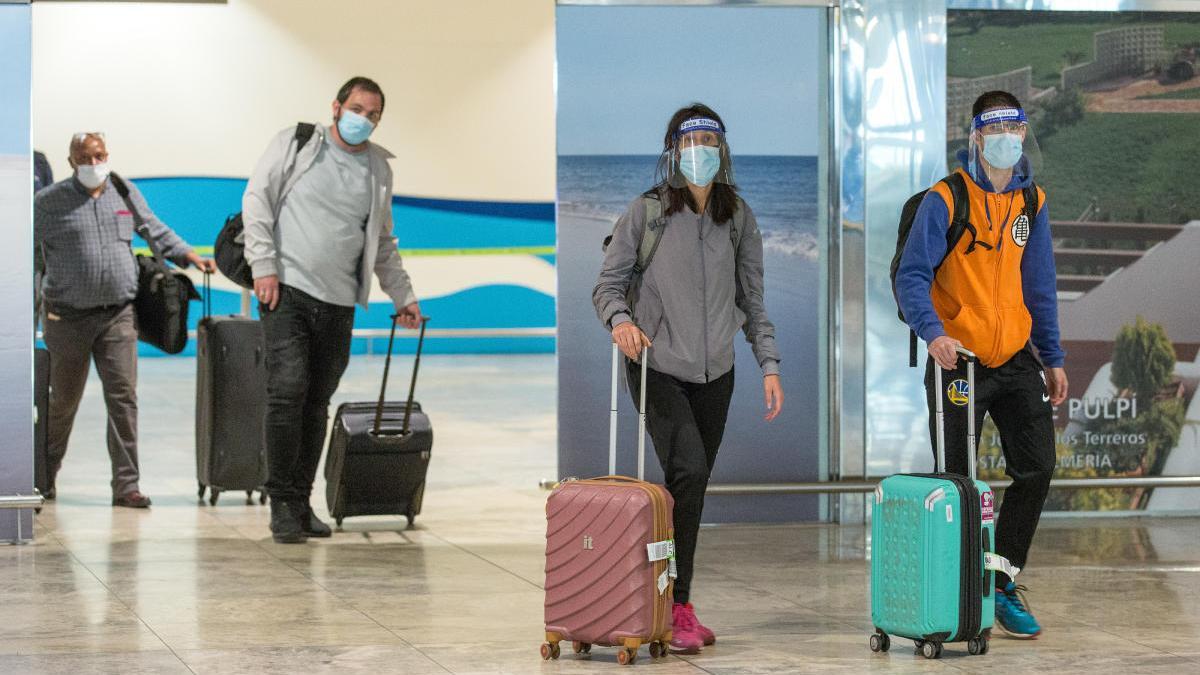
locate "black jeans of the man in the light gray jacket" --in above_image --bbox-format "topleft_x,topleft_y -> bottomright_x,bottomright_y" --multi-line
259,286 -> 354,503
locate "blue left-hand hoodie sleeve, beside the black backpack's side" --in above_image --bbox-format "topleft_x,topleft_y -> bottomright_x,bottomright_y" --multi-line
896,190 -> 950,342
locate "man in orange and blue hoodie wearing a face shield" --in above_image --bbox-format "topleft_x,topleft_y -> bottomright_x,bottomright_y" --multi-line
896,91 -> 1067,638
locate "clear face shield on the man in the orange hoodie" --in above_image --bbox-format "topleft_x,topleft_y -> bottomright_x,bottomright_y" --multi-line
967,108 -> 1042,190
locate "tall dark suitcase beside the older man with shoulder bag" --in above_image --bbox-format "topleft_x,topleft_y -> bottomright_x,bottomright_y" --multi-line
196,275 -> 266,506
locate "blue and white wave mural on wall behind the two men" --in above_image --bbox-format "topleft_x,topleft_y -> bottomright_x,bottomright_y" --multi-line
121,177 -> 556,356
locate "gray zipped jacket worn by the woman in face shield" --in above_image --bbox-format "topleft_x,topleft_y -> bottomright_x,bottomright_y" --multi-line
592,197 -> 779,382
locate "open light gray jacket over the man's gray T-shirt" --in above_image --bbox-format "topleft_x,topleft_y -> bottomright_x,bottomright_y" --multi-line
241,125 -> 416,310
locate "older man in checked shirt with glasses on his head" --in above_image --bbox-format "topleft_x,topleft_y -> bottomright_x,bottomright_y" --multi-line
34,132 -> 216,508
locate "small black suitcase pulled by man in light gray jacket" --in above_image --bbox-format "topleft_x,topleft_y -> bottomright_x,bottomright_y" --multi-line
325,317 -> 433,526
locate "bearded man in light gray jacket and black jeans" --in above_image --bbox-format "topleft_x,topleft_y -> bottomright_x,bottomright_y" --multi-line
242,77 -> 421,544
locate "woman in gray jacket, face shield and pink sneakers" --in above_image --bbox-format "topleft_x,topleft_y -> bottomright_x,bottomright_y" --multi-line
593,103 -> 784,653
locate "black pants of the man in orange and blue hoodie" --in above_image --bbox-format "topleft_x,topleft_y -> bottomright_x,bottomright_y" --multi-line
925,350 -> 1057,586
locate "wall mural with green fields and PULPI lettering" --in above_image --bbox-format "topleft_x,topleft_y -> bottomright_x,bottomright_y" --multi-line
945,11 -> 1200,510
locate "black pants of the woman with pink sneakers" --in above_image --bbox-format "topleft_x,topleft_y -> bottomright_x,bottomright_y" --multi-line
626,362 -> 733,603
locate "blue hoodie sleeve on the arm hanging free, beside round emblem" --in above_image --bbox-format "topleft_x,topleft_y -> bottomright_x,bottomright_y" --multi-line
1021,195 -> 1067,368
